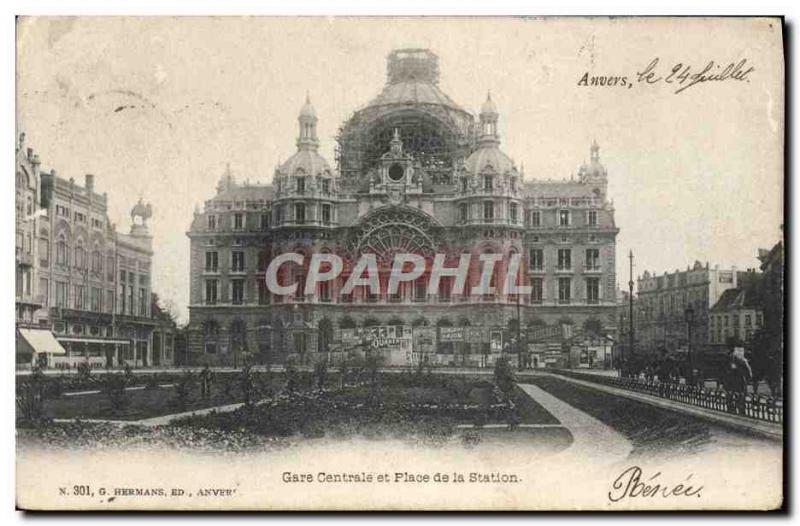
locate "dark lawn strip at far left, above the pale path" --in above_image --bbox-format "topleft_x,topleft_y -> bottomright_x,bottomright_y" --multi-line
45,386 -> 248,420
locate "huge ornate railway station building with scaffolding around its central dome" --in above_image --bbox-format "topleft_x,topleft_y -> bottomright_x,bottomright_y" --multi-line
188,49 -> 618,367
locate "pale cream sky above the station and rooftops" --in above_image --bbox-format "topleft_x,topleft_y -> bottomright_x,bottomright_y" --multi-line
16,17 -> 784,320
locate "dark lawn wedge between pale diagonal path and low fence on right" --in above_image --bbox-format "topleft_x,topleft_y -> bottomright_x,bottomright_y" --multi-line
525,376 -> 712,458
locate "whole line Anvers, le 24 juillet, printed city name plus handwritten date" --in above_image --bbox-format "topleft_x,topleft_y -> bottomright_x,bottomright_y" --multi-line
578,57 -> 755,94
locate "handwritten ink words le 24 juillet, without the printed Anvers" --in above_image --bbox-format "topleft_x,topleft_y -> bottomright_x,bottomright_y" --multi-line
636,57 -> 755,94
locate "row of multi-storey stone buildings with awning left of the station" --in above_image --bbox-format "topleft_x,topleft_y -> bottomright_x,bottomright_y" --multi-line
16,134 -> 174,367
